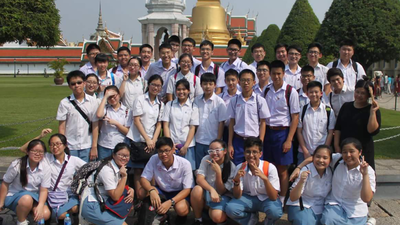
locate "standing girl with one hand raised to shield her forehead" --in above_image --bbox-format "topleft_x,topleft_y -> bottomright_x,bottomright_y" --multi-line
97,85 -> 132,160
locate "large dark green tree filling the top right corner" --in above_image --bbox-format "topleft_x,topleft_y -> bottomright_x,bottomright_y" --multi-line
316,0 -> 400,69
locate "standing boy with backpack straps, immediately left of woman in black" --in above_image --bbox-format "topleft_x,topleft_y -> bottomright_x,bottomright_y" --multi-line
297,81 -> 336,164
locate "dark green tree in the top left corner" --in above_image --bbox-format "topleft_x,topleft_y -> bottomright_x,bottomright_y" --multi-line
0,0 -> 60,47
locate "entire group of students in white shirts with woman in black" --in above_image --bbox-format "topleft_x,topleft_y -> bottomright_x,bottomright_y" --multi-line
0,36 -> 380,224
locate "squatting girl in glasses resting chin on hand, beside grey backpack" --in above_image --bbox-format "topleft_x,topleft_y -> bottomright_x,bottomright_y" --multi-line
81,143 -> 134,225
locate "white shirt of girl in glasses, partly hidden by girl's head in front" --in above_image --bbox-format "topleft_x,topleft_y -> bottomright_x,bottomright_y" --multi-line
167,71 -> 203,101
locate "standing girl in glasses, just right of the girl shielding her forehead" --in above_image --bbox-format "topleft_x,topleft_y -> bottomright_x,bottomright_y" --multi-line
126,74 -> 164,199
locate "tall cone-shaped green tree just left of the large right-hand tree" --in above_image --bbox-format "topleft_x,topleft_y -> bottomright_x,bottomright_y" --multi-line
277,0 -> 320,65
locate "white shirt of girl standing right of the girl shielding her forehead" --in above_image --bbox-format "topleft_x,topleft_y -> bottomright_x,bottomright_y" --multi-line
126,93 -> 164,142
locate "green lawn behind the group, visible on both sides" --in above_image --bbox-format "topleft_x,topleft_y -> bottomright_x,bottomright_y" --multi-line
0,77 -> 400,159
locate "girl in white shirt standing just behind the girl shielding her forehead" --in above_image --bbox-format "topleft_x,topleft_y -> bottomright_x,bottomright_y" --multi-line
119,57 -> 147,109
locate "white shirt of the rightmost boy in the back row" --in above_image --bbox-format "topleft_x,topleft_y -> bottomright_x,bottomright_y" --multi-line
326,59 -> 366,87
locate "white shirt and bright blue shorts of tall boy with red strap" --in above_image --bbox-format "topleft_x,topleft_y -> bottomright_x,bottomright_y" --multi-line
263,82 -> 300,165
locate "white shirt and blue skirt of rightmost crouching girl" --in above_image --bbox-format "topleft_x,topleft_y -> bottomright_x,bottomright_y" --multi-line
321,156 -> 376,225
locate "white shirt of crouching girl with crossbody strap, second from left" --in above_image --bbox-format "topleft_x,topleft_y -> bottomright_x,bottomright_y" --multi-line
43,153 -> 86,194
